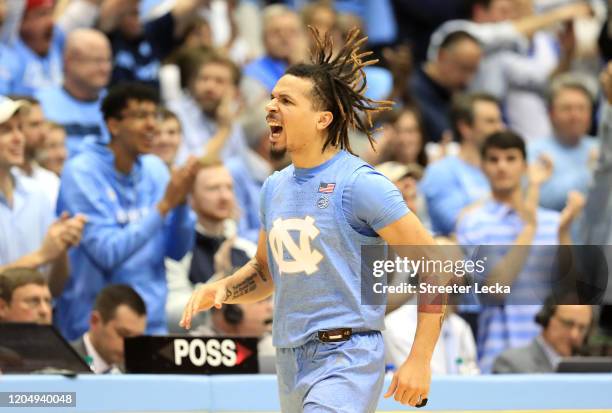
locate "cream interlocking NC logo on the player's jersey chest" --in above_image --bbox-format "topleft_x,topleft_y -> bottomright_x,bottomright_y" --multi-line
268,216 -> 323,275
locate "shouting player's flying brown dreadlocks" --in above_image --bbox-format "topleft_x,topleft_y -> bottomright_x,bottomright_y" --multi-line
285,26 -> 393,153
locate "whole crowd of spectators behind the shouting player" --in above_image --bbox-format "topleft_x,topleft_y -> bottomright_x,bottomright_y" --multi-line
0,0 -> 612,374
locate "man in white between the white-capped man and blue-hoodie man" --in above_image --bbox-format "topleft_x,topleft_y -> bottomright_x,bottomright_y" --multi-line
13,98 -> 59,208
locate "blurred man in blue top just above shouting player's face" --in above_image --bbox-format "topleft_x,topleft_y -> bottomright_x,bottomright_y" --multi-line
242,4 -> 307,107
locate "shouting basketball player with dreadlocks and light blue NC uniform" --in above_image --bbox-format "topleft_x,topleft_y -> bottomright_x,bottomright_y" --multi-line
181,29 -> 443,413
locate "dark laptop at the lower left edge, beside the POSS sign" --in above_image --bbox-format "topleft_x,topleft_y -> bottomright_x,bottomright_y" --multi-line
0,323 -> 92,375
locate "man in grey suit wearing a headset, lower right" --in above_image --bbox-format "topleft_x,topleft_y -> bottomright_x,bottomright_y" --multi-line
493,300 -> 593,374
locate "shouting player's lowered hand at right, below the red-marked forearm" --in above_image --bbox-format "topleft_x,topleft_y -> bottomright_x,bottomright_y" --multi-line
385,356 -> 431,407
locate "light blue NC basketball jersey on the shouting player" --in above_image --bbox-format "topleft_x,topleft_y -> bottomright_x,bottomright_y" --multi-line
262,151 -> 408,348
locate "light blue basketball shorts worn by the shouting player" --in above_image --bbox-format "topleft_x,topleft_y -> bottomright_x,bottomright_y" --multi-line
276,331 -> 385,413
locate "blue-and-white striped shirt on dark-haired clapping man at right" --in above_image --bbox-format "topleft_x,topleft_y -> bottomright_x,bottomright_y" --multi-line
457,199 -> 559,373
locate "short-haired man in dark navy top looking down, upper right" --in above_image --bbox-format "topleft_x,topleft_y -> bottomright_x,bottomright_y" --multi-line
409,31 -> 482,142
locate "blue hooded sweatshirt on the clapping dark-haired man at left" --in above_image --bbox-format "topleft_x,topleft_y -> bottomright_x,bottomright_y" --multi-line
54,143 -> 195,340
